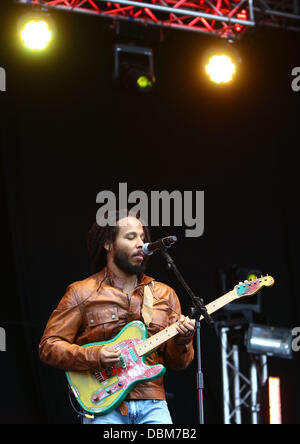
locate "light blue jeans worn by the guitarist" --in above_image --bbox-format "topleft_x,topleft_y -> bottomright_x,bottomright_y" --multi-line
82,399 -> 173,424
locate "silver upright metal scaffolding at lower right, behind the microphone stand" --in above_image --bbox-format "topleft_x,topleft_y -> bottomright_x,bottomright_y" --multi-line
220,326 -> 268,424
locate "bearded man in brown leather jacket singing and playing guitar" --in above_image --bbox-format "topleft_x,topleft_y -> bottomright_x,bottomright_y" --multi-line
39,213 -> 195,424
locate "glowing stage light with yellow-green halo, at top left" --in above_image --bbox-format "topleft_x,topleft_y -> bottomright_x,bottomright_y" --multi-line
18,12 -> 54,51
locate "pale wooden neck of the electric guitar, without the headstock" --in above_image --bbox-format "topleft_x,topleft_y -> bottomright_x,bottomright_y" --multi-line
136,291 -> 236,356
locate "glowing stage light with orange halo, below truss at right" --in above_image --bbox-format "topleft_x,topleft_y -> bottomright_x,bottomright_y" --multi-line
205,54 -> 236,83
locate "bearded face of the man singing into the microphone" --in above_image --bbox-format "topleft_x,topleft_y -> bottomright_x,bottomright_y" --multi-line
112,217 -> 146,274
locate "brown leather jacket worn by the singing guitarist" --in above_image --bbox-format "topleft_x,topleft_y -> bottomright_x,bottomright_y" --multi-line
39,269 -> 194,399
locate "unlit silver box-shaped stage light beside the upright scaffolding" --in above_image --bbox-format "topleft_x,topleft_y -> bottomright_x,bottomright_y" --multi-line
246,324 -> 293,359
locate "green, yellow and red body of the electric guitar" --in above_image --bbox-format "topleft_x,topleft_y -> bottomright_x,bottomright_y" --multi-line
66,321 -> 166,415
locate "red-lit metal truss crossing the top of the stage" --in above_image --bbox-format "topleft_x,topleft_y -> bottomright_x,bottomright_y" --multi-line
17,0 -> 255,39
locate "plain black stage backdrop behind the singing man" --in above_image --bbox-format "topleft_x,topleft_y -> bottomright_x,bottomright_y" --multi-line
0,2 -> 300,424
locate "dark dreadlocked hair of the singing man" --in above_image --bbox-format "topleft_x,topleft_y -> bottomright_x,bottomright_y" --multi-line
87,210 -> 151,274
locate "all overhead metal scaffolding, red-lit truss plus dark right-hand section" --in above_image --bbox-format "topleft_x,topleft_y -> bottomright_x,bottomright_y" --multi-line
15,0 -> 300,40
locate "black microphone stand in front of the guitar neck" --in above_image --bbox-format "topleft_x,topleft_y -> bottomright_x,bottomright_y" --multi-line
160,247 -> 214,424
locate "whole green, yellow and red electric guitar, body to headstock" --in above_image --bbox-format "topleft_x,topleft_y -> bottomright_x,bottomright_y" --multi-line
66,275 -> 274,415
